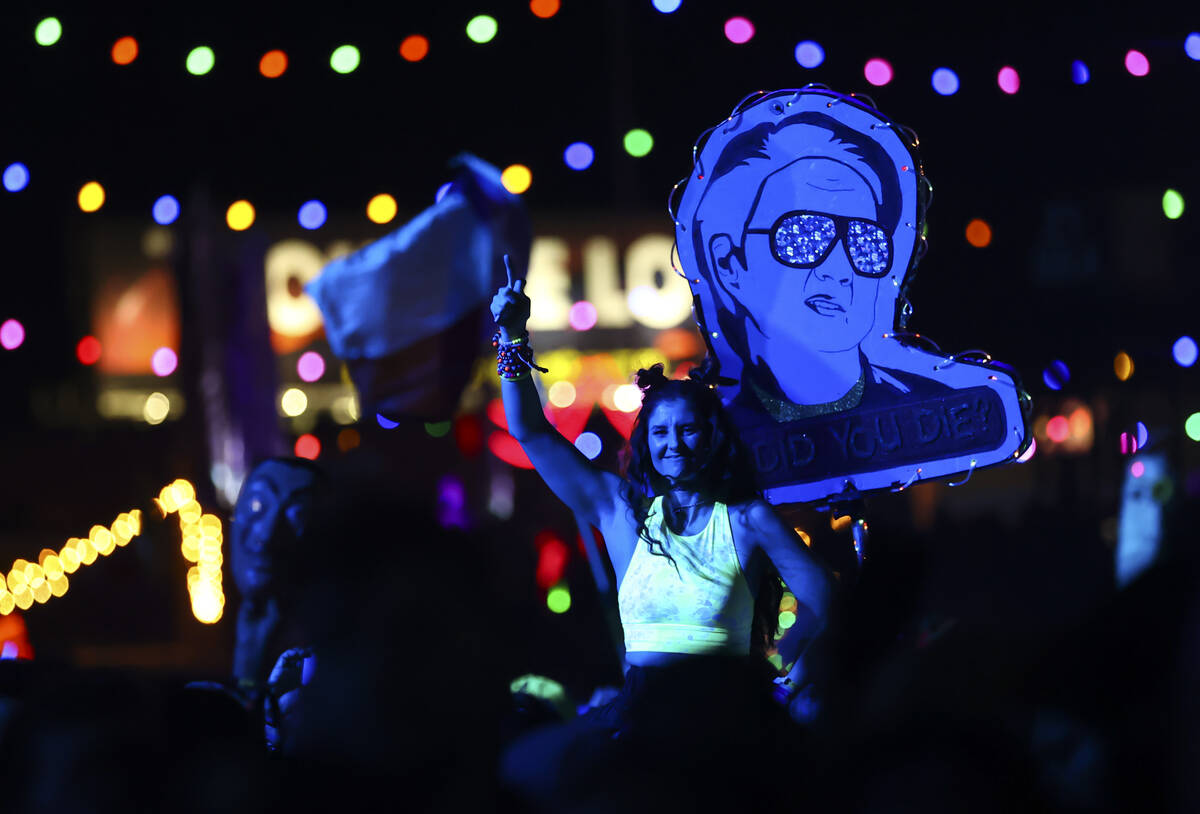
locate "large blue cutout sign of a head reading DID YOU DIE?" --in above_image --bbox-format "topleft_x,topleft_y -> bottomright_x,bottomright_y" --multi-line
672,88 -> 1030,503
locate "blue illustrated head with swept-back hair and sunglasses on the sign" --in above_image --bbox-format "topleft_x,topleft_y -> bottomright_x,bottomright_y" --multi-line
691,112 -> 914,415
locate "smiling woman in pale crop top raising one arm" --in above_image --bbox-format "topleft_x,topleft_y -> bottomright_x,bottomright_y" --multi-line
492,258 -> 832,792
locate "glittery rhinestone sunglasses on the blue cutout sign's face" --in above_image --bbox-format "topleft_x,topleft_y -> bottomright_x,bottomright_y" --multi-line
746,210 -> 892,277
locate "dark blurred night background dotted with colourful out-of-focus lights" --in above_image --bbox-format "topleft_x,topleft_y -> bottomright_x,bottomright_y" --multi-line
0,0 -> 1200,686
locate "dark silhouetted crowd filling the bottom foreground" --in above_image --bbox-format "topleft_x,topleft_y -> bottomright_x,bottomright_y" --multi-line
0,456 -> 1200,814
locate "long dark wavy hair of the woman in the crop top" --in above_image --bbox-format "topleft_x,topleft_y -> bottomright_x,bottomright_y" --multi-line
620,359 -> 784,656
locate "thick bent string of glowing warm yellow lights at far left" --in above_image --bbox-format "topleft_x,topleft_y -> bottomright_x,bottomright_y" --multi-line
0,479 -> 224,624
